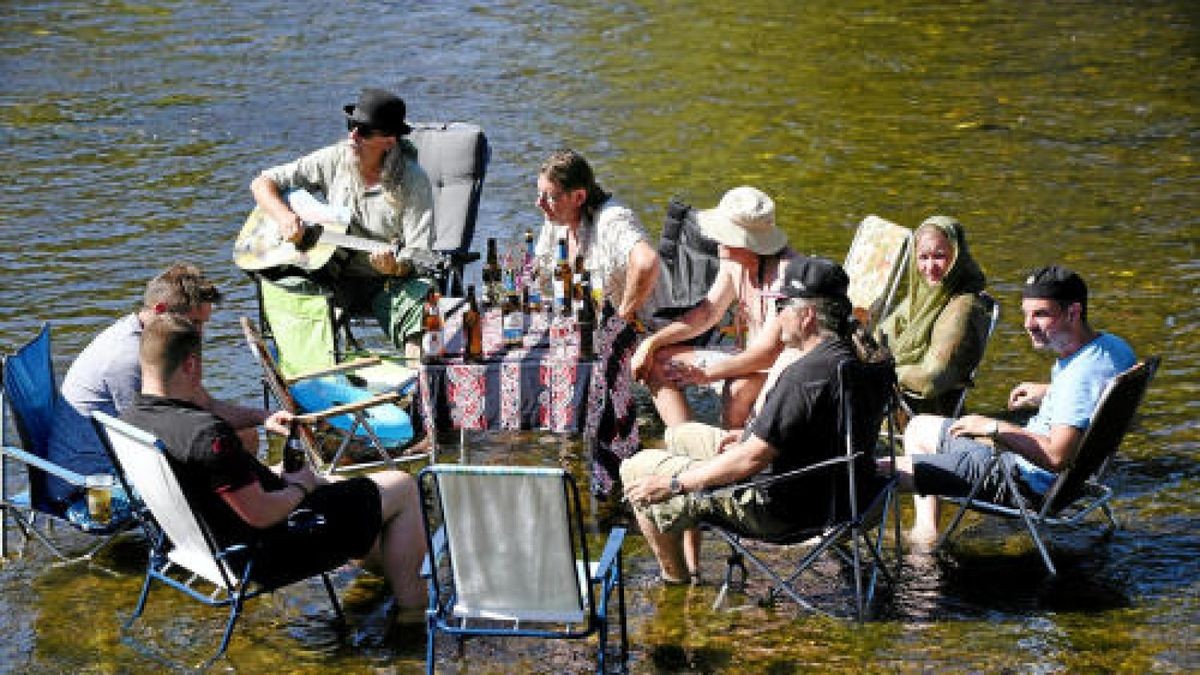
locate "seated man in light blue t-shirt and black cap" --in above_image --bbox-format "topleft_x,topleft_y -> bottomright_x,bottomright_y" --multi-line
896,265 -> 1136,544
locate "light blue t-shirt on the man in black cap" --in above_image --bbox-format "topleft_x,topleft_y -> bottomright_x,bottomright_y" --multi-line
1014,333 -> 1138,492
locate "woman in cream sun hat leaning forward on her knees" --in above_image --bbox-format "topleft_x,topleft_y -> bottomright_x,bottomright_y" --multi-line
631,186 -> 794,429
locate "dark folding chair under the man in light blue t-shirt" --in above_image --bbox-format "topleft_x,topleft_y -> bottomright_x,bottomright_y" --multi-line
936,357 -> 1159,575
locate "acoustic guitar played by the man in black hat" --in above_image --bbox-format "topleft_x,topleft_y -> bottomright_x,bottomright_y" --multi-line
233,190 -> 446,275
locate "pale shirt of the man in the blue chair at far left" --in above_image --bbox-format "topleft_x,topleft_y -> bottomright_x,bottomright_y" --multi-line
47,313 -> 142,500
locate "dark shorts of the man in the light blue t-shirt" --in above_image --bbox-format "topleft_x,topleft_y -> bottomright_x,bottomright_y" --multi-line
912,419 -> 1042,507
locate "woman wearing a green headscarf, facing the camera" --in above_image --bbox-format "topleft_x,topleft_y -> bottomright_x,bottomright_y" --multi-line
880,216 -> 989,414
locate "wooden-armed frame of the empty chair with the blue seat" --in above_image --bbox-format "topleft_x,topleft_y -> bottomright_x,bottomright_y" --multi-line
239,317 -> 427,474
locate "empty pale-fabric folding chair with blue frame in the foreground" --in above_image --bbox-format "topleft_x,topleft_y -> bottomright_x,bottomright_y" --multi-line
418,464 -> 629,674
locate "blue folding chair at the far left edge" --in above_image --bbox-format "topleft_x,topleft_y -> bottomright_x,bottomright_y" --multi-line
0,323 -> 134,562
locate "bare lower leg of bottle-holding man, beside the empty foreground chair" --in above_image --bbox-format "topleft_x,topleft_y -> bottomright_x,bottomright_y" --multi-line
368,471 -> 427,607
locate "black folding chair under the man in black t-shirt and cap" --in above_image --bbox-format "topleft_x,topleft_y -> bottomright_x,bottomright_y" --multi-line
703,360 -> 900,621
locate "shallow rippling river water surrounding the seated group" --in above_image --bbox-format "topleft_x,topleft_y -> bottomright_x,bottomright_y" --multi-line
0,0 -> 1200,673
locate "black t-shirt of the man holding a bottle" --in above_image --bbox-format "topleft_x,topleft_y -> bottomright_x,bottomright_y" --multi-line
121,395 -> 287,545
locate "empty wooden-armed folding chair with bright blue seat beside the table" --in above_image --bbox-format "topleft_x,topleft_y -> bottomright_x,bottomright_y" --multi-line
240,317 -> 426,473
